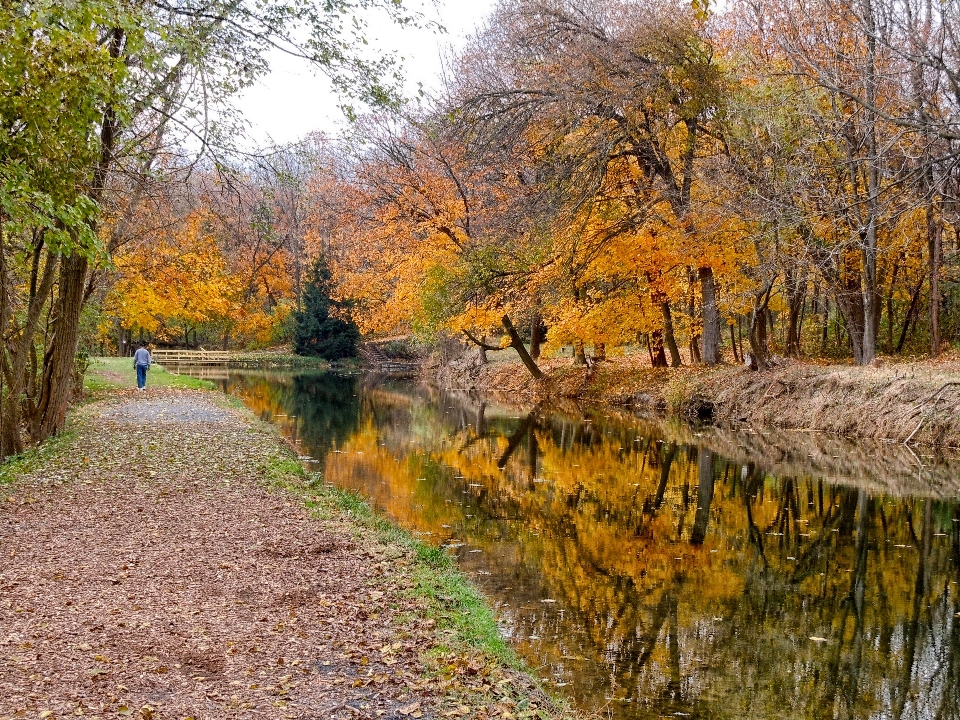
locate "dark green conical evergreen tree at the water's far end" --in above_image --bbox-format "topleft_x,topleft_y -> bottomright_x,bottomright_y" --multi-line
293,255 -> 360,360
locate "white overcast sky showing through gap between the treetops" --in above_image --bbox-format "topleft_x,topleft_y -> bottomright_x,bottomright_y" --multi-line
236,0 -> 495,145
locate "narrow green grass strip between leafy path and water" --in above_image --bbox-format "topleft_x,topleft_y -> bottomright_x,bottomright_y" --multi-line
263,452 -> 525,670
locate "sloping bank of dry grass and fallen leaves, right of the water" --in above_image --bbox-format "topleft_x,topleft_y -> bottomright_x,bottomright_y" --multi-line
443,356 -> 960,447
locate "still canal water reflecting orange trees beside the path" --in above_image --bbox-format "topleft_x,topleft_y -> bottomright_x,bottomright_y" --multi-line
204,373 -> 960,720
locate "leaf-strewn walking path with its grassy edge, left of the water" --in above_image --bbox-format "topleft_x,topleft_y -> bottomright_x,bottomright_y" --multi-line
0,382 -> 573,720
